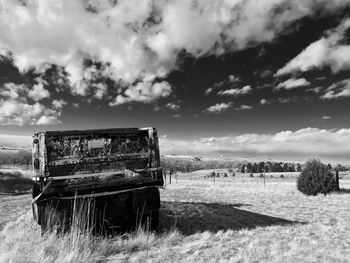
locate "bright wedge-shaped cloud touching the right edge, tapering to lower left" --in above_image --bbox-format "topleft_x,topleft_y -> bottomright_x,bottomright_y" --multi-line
276,18 -> 350,76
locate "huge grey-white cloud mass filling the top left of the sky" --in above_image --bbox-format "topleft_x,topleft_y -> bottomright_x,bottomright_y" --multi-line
0,0 -> 350,105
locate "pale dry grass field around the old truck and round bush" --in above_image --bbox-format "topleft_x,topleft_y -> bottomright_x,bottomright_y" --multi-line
0,171 -> 350,262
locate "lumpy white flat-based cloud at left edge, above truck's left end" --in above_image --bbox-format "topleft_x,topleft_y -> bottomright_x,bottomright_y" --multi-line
0,83 -> 66,126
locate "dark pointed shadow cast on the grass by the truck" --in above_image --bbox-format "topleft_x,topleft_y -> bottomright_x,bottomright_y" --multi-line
158,202 -> 305,235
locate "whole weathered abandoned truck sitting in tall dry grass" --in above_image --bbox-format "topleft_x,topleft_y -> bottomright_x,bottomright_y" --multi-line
32,128 -> 163,233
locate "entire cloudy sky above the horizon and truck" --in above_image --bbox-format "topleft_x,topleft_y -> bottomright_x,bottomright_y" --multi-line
0,0 -> 350,162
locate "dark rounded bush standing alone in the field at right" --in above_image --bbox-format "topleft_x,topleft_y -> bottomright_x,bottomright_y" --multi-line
297,159 -> 335,195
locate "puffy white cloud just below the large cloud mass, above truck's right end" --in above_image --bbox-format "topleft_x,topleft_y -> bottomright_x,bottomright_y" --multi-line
109,81 -> 171,106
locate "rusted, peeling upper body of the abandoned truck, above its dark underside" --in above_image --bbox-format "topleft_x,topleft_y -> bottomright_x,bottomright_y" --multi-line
33,128 -> 163,200
